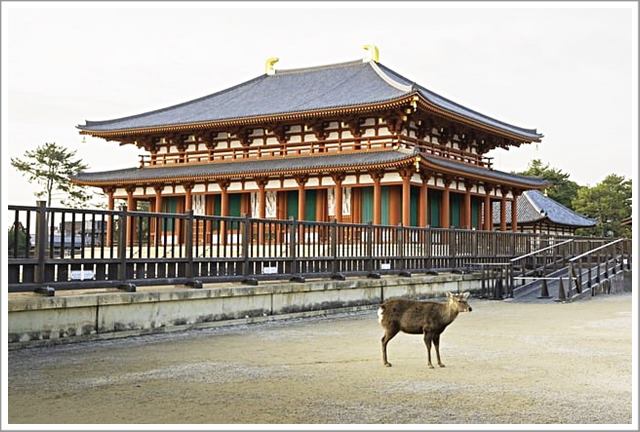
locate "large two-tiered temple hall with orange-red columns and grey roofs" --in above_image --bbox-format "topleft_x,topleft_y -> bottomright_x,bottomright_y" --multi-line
74,46 -> 547,241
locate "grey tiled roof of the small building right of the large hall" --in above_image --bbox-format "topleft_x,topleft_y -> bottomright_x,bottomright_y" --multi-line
493,190 -> 596,227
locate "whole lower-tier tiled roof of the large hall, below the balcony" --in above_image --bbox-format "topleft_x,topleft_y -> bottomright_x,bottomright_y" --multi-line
73,150 -> 547,189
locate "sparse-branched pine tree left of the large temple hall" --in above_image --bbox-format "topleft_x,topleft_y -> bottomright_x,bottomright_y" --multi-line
11,143 -> 91,207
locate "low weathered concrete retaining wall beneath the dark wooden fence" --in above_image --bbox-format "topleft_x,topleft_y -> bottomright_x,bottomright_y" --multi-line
9,274 -> 480,349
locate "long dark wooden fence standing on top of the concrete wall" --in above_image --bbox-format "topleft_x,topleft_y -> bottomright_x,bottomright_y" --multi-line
9,202 -> 620,292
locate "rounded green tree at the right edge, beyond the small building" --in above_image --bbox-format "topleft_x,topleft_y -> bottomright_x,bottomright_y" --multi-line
573,174 -> 632,237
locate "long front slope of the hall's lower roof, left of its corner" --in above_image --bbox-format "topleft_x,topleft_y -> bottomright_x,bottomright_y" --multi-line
74,151 -> 415,184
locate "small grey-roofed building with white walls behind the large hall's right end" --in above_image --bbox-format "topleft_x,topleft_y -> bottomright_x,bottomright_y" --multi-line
493,190 -> 596,234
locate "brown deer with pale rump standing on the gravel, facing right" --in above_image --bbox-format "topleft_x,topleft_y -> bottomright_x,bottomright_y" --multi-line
378,292 -> 471,369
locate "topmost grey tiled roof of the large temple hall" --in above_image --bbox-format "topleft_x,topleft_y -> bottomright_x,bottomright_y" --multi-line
78,60 -> 542,141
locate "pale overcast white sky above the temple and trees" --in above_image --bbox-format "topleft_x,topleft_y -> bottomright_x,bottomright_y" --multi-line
2,3 -> 637,204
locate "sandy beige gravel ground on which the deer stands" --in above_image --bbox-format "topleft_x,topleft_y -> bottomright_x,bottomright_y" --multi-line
9,294 -> 632,424
